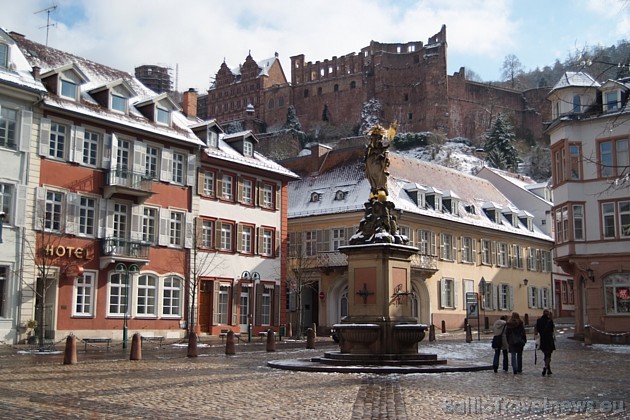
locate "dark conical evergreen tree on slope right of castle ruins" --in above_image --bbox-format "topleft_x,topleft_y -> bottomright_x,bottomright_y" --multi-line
485,114 -> 520,172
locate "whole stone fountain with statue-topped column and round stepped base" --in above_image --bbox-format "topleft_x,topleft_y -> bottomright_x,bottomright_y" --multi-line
268,125 -> 492,373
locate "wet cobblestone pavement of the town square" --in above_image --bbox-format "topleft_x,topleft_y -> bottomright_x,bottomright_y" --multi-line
0,325 -> 630,420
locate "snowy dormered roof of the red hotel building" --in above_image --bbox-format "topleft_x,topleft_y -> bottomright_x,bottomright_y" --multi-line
12,30 -> 204,146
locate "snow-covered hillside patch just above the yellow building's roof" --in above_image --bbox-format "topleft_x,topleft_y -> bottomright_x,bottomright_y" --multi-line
390,141 -> 484,175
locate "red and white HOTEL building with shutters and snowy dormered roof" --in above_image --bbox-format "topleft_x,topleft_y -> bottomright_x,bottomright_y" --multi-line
11,33 -> 205,340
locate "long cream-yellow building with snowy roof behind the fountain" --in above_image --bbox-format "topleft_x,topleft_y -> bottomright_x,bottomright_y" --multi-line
283,146 -> 553,333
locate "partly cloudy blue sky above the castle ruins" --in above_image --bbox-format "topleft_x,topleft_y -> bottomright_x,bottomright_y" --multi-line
0,0 -> 630,92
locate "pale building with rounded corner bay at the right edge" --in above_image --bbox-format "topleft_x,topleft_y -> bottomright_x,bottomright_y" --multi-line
547,72 -> 630,343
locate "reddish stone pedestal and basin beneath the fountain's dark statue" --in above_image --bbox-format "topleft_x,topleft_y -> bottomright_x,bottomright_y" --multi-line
336,243 -> 426,355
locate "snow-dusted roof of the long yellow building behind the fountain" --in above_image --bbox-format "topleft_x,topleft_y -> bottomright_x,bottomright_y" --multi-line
288,153 -> 552,241
